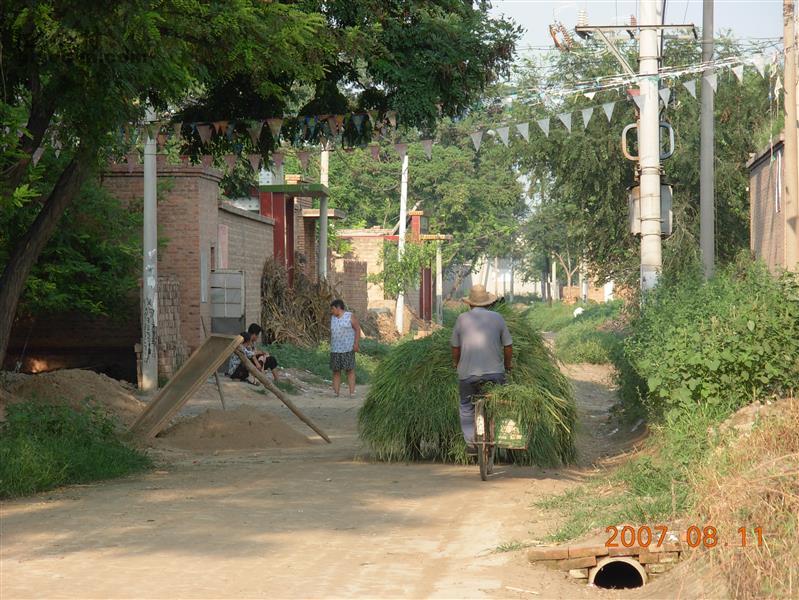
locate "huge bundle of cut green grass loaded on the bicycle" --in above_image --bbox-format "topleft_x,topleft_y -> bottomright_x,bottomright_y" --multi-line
358,305 -> 576,466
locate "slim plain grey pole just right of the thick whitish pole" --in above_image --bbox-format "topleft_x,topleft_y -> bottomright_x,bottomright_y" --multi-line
699,0 -> 716,279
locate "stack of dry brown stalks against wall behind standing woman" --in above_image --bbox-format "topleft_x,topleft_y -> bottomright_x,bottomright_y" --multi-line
261,260 -> 339,347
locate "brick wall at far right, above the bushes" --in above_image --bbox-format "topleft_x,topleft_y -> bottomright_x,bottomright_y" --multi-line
749,143 -> 785,271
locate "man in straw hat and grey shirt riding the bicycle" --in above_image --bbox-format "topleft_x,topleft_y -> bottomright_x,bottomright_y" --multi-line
450,285 -> 513,454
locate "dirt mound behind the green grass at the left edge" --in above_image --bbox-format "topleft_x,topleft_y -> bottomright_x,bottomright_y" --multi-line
7,369 -> 144,425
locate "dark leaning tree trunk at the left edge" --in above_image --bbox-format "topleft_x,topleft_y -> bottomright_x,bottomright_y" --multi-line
0,155 -> 89,368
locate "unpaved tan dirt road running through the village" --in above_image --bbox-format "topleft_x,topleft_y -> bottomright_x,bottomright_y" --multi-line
0,367 -> 615,599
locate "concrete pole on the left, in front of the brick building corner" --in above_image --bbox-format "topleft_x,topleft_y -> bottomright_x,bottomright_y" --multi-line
141,108 -> 158,392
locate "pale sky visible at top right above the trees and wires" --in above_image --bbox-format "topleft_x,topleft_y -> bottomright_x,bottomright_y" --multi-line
491,0 -> 782,56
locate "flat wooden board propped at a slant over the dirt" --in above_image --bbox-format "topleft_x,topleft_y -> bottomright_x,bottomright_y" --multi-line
130,333 -> 243,438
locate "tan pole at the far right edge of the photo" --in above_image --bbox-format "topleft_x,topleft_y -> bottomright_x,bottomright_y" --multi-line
782,0 -> 799,271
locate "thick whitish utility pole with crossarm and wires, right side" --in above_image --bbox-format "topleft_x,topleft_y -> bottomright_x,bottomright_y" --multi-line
638,0 -> 663,290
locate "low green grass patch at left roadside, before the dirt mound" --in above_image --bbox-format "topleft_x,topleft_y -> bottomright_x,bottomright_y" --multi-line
0,403 -> 151,498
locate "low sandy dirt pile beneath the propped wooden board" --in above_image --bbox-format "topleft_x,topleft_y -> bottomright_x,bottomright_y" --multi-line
158,406 -> 311,452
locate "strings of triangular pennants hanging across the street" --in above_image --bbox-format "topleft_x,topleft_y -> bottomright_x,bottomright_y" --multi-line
115,49 -> 782,172
